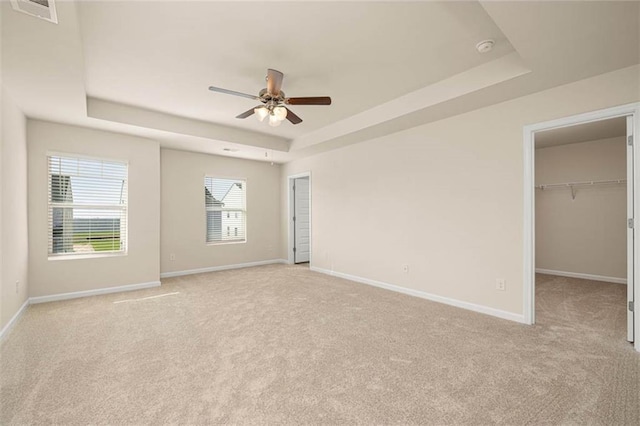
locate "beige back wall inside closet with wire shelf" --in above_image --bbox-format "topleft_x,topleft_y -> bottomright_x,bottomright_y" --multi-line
535,137 -> 627,278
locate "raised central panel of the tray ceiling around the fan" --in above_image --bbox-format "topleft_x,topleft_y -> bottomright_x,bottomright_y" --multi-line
79,2 -> 513,139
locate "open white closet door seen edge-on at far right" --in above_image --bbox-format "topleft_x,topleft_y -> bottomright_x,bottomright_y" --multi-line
627,115 -> 636,342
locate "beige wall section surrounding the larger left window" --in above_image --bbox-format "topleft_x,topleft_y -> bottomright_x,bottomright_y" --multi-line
27,120 -> 160,297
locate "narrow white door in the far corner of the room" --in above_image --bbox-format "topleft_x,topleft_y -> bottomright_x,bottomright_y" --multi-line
293,177 -> 311,263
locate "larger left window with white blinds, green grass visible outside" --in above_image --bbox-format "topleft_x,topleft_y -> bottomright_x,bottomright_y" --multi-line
48,155 -> 128,257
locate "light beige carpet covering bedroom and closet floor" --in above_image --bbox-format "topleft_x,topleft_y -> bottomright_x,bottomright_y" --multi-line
0,265 -> 640,425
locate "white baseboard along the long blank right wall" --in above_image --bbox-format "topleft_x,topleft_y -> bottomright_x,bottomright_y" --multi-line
310,266 -> 525,324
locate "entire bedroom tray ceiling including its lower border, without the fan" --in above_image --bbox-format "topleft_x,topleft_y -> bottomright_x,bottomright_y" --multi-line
0,0 -> 640,162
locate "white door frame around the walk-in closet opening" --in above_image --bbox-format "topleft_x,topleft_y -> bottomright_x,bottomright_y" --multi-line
523,103 -> 640,352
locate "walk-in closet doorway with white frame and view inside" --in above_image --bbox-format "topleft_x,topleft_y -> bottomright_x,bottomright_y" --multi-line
524,105 -> 640,350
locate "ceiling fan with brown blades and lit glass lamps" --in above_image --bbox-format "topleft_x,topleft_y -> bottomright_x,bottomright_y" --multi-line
209,69 -> 331,127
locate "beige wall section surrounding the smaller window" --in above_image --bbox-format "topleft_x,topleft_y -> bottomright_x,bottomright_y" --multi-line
160,149 -> 281,273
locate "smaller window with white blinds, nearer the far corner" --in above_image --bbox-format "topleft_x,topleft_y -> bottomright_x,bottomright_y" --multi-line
204,176 -> 247,243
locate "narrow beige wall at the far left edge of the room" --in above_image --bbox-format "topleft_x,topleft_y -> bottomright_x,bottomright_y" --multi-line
0,88 -> 29,330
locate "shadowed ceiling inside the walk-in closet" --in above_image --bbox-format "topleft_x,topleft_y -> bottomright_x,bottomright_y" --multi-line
535,117 -> 627,149
